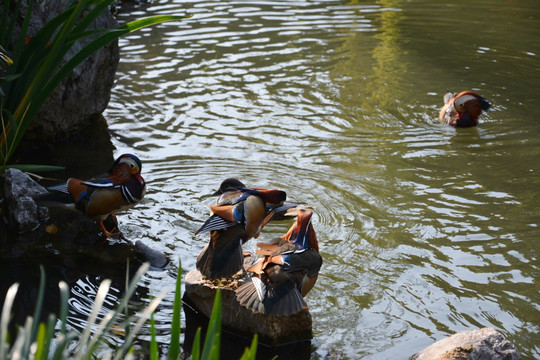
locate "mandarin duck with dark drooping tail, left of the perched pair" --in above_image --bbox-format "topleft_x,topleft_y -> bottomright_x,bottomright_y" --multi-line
195,178 -> 287,279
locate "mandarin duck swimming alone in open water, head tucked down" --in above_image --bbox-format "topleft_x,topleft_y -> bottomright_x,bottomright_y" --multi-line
439,91 -> 491,127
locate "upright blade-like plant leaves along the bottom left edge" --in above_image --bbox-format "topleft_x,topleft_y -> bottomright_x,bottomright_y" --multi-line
0,264 -> 257,360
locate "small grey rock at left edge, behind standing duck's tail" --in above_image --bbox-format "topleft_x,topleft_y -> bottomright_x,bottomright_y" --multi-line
4,169 -> 47,233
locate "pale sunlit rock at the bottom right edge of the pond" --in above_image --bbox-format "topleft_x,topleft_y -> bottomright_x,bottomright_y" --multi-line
410,328 -> 521,360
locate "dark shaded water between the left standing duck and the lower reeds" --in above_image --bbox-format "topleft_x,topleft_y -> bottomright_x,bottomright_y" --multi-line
0,202 -> 150,338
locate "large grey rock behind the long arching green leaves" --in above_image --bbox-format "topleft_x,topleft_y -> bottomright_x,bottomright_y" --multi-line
0,0 -> 120,143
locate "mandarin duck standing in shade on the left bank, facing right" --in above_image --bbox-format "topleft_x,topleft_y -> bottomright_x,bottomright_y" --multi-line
40,154 -> 146,237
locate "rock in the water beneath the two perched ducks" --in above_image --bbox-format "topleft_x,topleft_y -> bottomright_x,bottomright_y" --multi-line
184,270 -> 313,346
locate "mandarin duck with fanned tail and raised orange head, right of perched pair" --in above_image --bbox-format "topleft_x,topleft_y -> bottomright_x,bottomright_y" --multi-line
236,209 -> 322,316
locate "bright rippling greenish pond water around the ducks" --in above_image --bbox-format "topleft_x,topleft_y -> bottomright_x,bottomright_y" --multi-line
4,0 -> 540,359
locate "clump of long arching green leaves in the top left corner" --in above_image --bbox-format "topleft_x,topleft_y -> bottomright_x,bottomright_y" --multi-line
0,0 -> 190,166
